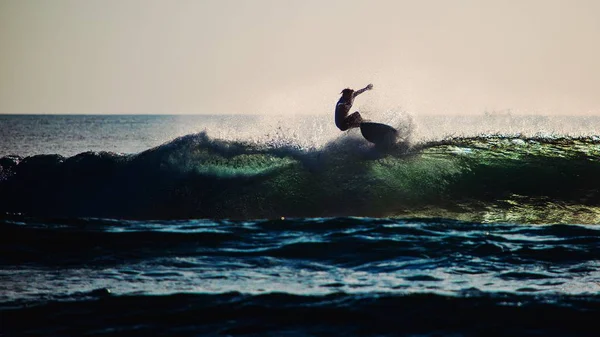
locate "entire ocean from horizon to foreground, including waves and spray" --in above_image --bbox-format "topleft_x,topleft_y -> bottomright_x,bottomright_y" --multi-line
0,113 -> 600,336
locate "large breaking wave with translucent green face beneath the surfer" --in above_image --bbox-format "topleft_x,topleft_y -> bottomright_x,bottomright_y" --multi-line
0,133 -> 600,223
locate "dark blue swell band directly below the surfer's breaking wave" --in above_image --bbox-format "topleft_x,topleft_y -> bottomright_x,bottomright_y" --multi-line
0,216 -> 600,268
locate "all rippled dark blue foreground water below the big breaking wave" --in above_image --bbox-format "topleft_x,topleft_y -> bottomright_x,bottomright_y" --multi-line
0,216 -> 600,336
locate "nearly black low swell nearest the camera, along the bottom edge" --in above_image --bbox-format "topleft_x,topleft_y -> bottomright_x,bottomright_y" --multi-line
0,291 -> 600,336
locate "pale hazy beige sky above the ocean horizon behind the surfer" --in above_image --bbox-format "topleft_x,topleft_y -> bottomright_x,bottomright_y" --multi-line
0,0 -> 600,115
